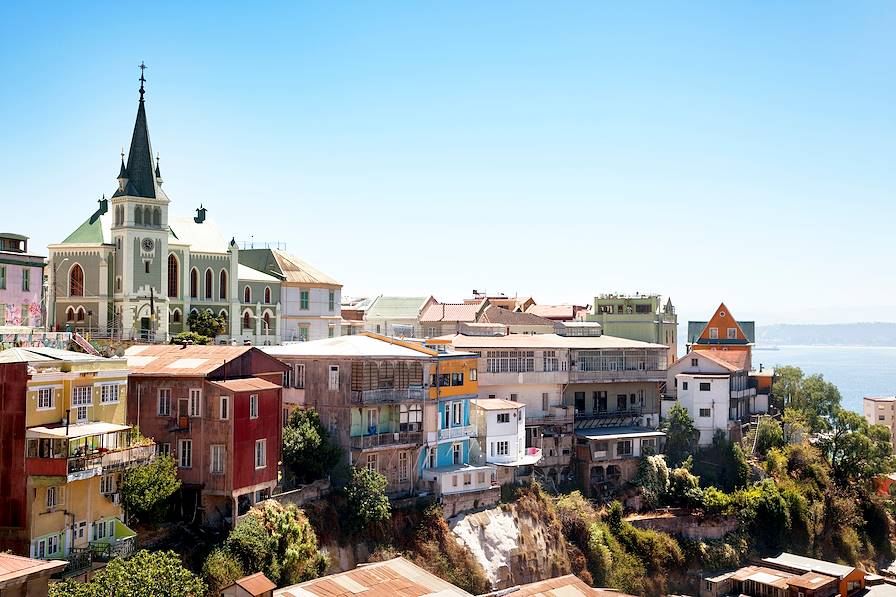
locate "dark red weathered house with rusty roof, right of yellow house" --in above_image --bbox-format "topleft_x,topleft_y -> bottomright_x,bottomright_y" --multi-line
126,345 -> 287,525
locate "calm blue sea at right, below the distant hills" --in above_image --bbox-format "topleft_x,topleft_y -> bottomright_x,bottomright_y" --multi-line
753,346 -> 896,413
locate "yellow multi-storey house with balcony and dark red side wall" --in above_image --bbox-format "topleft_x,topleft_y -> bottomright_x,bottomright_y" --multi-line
0,348 -> 155,572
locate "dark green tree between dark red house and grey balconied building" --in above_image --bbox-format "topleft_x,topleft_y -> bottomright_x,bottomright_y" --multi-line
283,408 -> 342,483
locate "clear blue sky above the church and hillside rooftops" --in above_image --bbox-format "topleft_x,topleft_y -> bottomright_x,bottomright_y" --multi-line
0,1 -> 896,323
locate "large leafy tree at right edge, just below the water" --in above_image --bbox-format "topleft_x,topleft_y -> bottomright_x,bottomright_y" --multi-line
819,408 -> 894,484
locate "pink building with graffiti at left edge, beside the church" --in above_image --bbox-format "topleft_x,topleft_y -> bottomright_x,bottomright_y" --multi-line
0,232 -> 47,328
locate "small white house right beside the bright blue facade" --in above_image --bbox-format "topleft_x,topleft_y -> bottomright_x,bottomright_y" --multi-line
470,398 -> 541,483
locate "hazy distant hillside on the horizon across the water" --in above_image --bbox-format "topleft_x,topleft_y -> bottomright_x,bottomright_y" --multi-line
756,322 -> 896,346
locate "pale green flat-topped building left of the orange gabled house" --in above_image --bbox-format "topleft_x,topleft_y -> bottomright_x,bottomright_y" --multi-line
587,294 -> 678,364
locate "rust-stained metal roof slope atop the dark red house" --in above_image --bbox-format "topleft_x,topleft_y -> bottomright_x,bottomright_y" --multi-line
124,344 -> 257,377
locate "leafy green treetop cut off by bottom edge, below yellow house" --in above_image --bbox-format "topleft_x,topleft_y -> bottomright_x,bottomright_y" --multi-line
49,550 -> 206,597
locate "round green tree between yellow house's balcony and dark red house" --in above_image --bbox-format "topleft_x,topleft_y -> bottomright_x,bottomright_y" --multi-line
121,456 -> 180,522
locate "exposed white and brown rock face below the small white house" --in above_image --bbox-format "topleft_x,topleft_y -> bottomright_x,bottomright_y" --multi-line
451,498 -> 572,590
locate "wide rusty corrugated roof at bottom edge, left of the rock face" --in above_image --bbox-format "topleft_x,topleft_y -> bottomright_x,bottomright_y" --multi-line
274,558 -> 472,597
